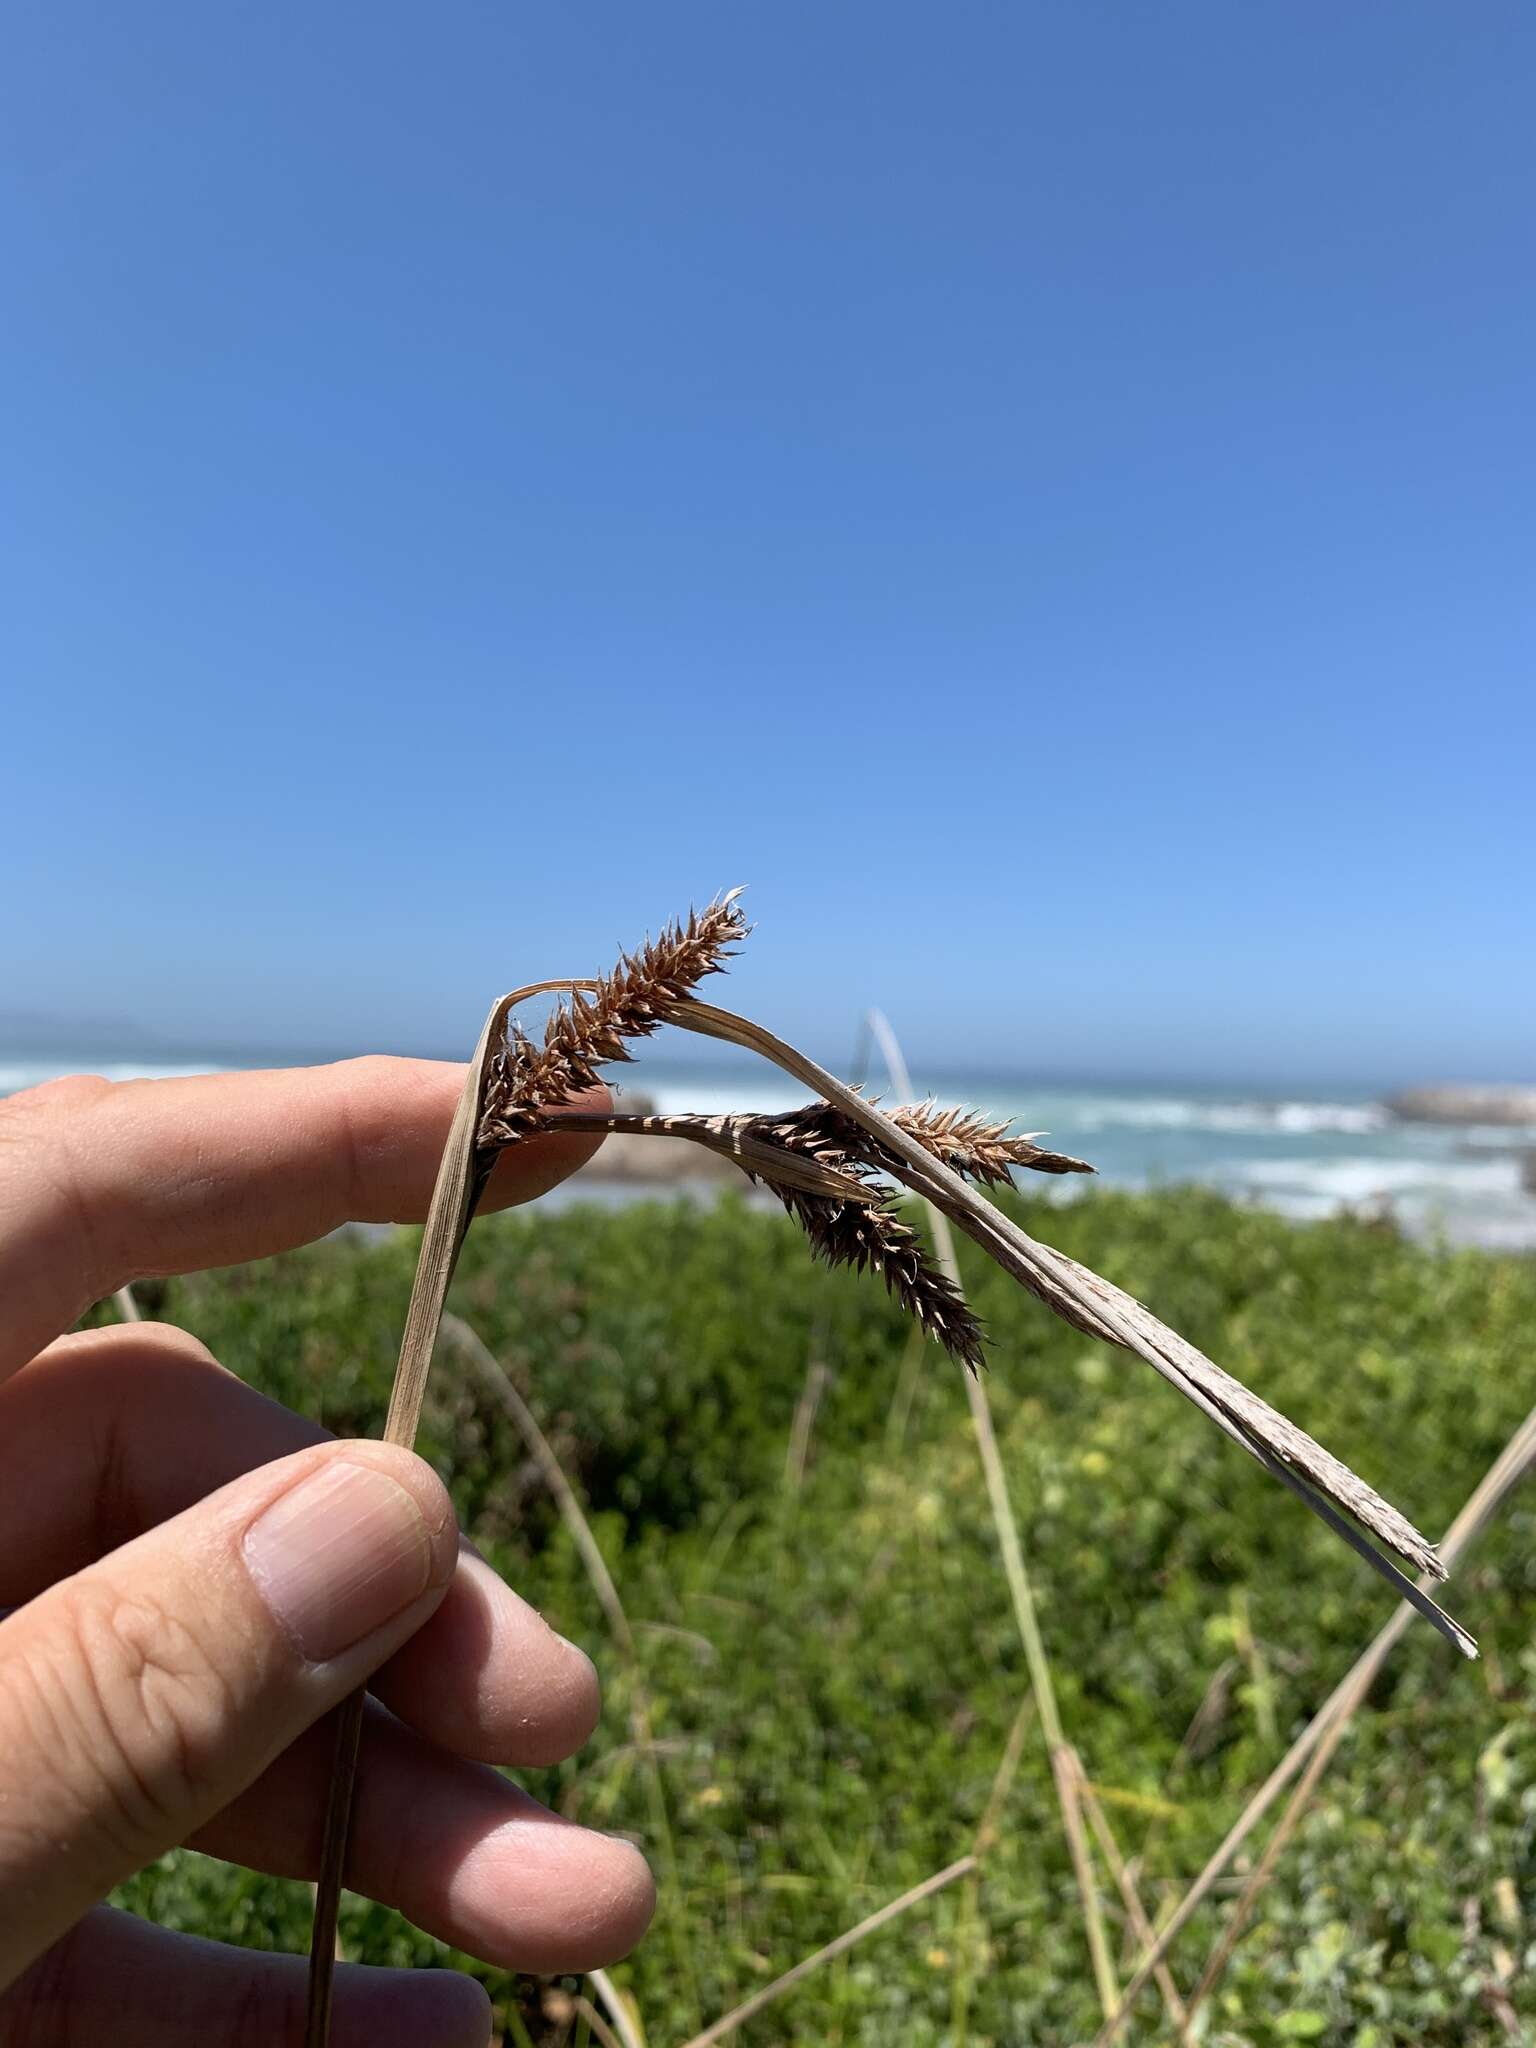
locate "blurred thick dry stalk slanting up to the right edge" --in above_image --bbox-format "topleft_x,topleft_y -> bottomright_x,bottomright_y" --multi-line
1094,1409 -> 1536,2048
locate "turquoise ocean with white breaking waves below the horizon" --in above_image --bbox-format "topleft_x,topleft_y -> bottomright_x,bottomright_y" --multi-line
0,1053 -> 1536,1251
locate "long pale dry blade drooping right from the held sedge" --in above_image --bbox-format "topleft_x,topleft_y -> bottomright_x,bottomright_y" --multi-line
672,999 -> 1477,1657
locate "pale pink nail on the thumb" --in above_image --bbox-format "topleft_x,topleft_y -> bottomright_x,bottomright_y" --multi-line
246,1458 -> 432,1663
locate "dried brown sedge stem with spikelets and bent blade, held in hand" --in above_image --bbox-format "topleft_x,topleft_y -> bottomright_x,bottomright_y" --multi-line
305,891 -> 1477,2048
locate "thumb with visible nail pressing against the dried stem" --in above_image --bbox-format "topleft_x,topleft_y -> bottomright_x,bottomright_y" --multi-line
0,1442 -> 459,1985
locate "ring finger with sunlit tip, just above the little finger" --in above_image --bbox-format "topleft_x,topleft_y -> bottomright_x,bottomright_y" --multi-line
193,1706 -> 655,1974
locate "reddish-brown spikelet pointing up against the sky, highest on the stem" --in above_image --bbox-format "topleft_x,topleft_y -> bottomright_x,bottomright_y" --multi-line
477,889 -> 748,1149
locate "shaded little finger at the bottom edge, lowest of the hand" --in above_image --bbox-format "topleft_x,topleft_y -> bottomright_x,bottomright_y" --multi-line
0,1907 -> 492,2048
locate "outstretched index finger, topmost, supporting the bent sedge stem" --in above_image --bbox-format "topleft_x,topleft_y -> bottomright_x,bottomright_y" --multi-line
0,1059 -> 606,1378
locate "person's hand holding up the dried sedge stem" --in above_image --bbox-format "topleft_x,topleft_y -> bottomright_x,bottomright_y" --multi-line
0,1059 -> 653,2048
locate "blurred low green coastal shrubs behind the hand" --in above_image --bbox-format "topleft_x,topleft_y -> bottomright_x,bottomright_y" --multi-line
98,1190 -> 1536,2048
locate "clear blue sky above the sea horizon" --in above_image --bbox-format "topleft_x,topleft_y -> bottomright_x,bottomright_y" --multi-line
0,0 -> 1536,1081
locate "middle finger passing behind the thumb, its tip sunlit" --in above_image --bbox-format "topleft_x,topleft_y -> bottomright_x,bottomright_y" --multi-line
0,1323 -> 600,1765
